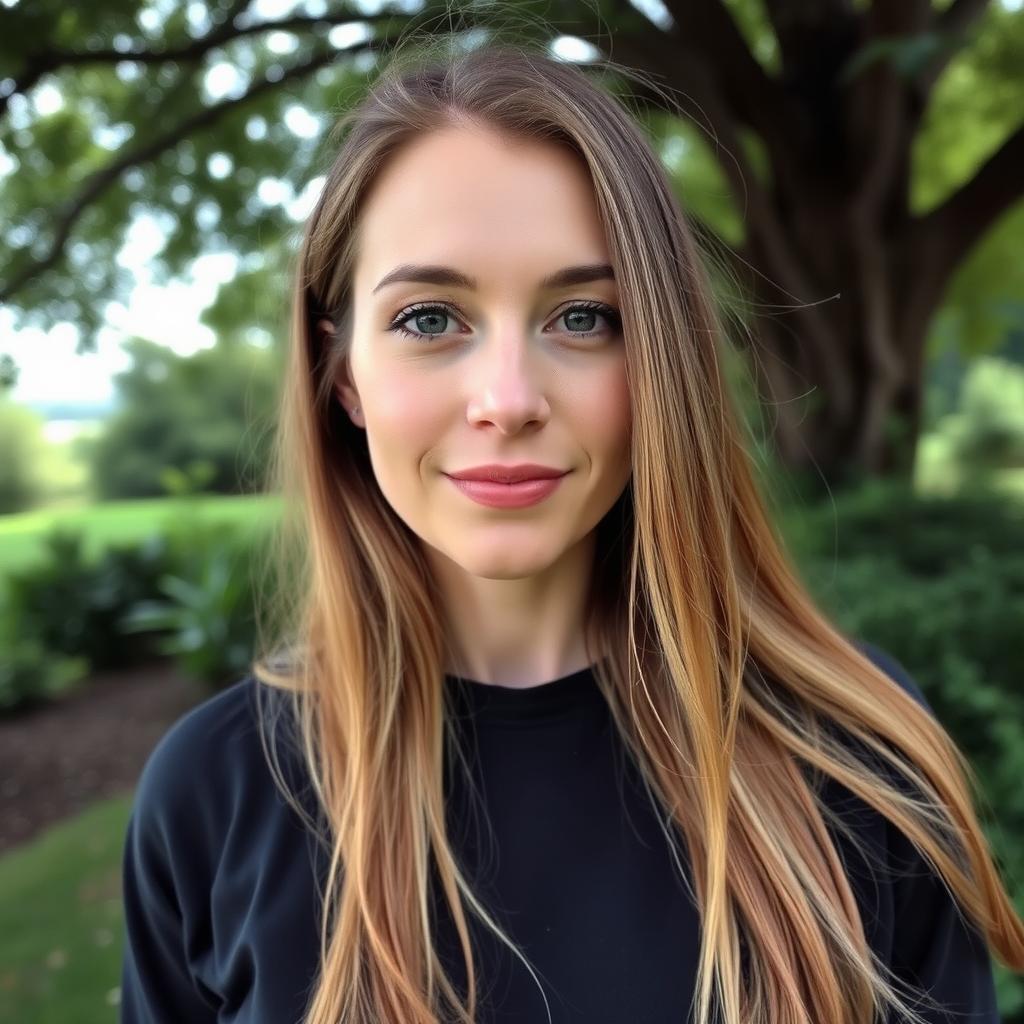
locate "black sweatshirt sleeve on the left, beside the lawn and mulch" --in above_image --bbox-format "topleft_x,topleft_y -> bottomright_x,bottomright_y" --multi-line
120,731 -> 220,1024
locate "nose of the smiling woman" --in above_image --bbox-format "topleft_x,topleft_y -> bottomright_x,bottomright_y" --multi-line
466,329 -> 551,434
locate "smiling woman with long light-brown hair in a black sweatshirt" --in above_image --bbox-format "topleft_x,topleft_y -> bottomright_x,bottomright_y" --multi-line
122,34 -> 1024,1024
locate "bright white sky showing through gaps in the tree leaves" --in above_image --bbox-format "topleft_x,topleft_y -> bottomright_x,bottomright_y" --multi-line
0,0 -> 1024,403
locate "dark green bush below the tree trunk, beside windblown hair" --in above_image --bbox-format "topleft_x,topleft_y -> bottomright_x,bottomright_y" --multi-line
786,484 -> 1024,1021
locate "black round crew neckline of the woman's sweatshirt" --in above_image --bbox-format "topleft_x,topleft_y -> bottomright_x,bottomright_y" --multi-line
444,665 -> 607,724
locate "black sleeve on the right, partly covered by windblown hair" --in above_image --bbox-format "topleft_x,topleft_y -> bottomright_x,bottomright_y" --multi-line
863,644 -> 1001,1024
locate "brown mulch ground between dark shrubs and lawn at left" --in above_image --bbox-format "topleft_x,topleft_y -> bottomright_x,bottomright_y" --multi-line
0,660 -> 205,853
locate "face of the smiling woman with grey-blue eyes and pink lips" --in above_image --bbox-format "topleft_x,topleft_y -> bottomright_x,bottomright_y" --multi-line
327,128 -> 631,580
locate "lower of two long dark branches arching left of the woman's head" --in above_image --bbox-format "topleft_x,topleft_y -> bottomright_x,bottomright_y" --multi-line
0,40 -> 372,302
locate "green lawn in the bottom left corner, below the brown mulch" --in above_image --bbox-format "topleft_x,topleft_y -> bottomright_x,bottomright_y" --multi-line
0,795 -> 131,1024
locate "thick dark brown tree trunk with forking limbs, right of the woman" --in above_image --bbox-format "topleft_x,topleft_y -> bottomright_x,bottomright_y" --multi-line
613,0 -> 1024,489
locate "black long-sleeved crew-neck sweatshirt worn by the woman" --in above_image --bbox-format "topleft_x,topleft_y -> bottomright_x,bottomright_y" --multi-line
120,644 -> 999,1024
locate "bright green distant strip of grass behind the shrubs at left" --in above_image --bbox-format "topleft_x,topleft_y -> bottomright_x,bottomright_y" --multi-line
0,495 -> 280,574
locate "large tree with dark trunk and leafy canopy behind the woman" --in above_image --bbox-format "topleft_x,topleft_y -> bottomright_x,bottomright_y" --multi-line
0,0 -> 1024,483
